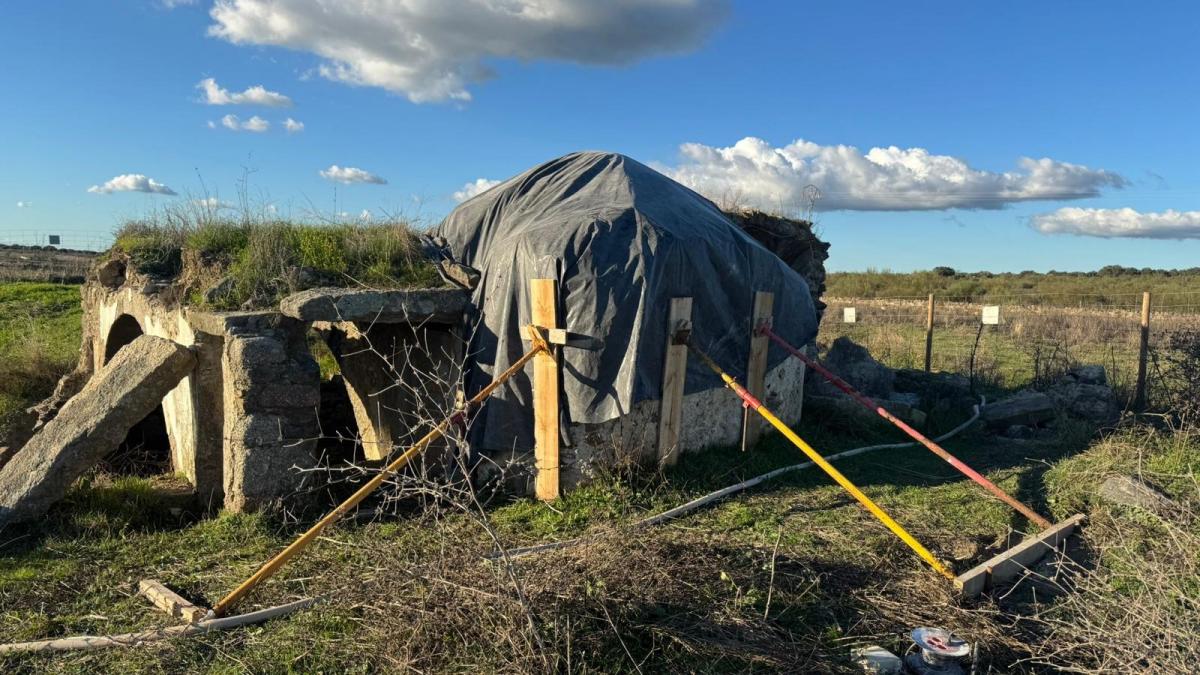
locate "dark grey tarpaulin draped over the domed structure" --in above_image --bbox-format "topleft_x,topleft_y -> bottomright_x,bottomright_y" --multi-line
434,153 -> 817,450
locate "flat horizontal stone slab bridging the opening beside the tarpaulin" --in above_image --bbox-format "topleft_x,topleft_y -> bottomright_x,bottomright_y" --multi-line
280,288 -> 470,323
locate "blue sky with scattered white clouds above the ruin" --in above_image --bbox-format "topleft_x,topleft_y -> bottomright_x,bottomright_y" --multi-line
0,0 -> 1200,270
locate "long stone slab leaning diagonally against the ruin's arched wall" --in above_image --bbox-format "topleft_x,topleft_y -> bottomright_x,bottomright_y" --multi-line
0,335 -> 196,527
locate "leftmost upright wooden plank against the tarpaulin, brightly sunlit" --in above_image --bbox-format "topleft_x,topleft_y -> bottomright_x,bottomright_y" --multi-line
529,279 -> 559,502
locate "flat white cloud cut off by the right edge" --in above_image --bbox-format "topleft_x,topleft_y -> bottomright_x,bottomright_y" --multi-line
1030,208 -> 1200,239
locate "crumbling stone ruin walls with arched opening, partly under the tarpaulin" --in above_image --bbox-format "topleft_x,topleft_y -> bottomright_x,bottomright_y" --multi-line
0,163 -> 828,520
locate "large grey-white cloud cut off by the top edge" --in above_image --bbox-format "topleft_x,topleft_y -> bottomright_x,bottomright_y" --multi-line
209,0 -> 728,102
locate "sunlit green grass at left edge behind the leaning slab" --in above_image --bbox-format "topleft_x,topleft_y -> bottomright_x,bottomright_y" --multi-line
0,282 -> 82,428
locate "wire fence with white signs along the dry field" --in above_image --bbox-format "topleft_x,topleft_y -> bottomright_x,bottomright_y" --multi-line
817,292 -> 1200,404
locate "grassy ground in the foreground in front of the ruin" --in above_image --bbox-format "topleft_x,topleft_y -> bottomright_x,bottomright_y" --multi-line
0,408 -> 1086,673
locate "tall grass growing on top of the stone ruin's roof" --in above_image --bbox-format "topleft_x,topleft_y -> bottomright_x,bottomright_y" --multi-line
112,216 -> 442,309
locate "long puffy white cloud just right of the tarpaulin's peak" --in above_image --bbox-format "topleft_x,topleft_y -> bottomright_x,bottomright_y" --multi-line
660,137 -> 1128,211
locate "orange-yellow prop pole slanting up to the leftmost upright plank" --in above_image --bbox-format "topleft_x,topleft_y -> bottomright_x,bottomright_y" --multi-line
212,341 -> 546,616
